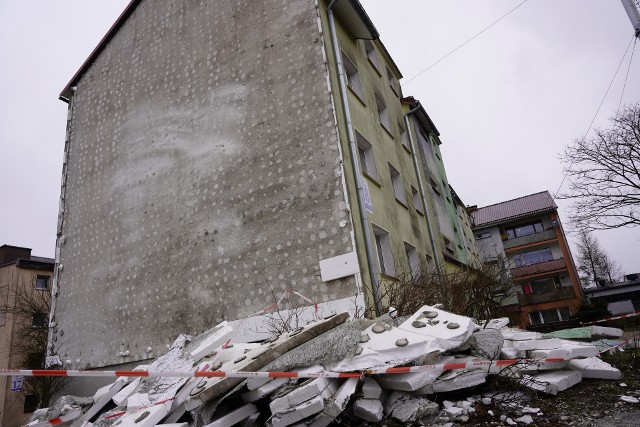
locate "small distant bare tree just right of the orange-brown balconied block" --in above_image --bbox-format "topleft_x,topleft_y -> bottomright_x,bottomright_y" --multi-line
577,230 -> 622,288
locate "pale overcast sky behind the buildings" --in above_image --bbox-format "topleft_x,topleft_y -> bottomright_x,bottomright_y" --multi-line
0,0 -> 640,273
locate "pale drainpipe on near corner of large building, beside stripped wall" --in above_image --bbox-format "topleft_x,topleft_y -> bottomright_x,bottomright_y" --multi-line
327,0 -> 382,316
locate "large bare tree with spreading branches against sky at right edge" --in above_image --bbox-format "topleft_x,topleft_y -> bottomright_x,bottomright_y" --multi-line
559,104 -> 640,230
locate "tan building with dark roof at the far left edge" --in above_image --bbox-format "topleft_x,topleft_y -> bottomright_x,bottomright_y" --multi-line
0,245 -> 54,427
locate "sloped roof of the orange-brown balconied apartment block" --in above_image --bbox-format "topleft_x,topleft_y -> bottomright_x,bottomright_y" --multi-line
471,190 -> 558,227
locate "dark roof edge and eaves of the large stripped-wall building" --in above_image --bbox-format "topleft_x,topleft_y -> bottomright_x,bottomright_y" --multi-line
58,0 -> 380,102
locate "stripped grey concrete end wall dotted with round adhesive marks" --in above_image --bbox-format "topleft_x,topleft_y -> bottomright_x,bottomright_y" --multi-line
53,0 -> 356,368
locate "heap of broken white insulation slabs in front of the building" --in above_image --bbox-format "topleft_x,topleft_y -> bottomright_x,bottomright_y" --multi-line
28,306 -> 622,427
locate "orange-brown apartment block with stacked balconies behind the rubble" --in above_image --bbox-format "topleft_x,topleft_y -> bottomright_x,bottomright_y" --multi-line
471,191 -> 582,326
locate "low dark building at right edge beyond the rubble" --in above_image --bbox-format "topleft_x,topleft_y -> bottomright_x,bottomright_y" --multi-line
584,273 -> 640,315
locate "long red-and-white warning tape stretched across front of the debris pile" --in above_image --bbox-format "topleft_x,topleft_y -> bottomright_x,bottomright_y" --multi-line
0,357 -> 574,378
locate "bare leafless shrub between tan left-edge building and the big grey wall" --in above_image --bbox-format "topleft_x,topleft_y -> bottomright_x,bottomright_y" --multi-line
0,284 -> 67,407
